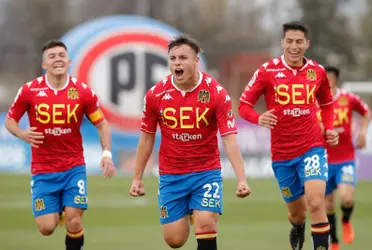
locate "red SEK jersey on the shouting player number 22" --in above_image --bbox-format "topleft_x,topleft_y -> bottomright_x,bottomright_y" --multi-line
141,73 -> 237,174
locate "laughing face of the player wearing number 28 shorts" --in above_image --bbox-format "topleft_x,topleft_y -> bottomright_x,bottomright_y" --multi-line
281,30 -> 310,66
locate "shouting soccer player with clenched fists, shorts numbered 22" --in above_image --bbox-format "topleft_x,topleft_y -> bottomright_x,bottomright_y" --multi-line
129,35 -> 251,250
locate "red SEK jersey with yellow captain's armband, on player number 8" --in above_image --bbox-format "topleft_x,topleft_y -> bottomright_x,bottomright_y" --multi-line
8,75 -> 104,174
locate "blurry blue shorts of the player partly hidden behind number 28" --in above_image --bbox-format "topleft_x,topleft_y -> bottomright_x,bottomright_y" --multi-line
326,161 -> 357,195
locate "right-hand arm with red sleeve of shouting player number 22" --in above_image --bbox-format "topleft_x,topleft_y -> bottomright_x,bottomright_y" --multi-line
216,89 -> 251,198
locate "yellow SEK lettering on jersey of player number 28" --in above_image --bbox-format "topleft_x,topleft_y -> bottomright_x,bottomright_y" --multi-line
274,84 -> 316,105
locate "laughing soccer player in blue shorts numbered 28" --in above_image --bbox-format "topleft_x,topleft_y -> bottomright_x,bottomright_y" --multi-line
239,22 -> 338,250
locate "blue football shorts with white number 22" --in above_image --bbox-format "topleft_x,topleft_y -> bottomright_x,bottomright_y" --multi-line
158,169 -> 223,224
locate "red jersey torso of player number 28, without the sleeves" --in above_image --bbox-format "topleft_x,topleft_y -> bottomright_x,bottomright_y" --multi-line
265,59 -> 324,160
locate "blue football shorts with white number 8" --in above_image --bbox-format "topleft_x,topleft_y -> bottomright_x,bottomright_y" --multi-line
31,165 -> 88,217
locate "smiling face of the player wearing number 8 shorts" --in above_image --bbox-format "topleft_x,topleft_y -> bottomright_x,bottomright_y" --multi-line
42,47 -> 71,76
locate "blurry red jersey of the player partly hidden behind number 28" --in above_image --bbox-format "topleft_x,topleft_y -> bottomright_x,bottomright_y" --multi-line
318,89 -> 369,163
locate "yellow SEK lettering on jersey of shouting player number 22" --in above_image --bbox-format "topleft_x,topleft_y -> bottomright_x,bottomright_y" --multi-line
160,107 -> 209,129
